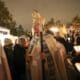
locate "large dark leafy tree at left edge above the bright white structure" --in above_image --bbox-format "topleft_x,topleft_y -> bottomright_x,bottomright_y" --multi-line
0,0 -> 16,32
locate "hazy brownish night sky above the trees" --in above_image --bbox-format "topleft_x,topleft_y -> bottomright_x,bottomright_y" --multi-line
2,0 -> 80,28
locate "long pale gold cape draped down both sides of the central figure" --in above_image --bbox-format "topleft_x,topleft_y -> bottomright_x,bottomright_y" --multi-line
26,35 -> 68,80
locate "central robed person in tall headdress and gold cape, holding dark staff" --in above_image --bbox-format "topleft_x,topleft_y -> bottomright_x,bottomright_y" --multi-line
27,11 -> 68,80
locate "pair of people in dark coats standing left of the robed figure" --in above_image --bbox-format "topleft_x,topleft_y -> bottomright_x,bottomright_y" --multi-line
3,38 -> 29,80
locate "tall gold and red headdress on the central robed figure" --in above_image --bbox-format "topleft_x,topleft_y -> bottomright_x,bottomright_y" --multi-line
32,10 -> 45,34
